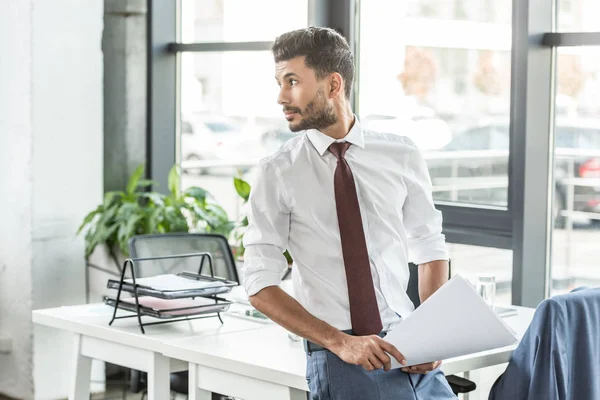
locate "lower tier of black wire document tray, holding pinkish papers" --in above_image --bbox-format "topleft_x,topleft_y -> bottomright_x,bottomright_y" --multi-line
104,296 -> 231,319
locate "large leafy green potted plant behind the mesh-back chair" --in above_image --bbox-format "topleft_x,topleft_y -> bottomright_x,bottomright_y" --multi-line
77,165 -> 234,300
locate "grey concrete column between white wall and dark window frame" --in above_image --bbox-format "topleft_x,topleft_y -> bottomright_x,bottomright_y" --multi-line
102,0 -> 147,191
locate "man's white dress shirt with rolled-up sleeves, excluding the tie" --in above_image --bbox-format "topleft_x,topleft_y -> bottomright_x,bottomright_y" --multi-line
242,118 -> 448,330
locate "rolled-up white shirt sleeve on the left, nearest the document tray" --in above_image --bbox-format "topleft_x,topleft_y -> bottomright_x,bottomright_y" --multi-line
242,162 -> 290,296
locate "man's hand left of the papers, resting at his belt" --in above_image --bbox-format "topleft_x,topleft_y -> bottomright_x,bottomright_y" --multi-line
329,334 -> 406,371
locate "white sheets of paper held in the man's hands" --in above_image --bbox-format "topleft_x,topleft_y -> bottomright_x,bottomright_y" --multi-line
384,275 -> 517,368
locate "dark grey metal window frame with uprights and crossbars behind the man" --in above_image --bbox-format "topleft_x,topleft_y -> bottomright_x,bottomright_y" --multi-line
147,0 -> 600,306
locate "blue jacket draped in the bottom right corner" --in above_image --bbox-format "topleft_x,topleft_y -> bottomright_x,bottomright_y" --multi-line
489,288 -> 600,400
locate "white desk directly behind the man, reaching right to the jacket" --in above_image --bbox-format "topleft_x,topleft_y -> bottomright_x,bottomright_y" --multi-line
163,308 -> 535,400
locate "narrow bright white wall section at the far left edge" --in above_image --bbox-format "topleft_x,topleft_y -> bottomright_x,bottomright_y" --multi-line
0,0 -> 33,398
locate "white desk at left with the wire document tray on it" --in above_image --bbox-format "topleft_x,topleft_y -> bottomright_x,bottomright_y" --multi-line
32,303 -> 265,400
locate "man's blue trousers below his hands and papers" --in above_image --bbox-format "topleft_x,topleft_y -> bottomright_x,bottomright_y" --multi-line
306,350 -> 457,400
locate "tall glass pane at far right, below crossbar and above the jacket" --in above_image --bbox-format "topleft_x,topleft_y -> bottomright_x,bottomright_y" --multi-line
551,47 -> 600,294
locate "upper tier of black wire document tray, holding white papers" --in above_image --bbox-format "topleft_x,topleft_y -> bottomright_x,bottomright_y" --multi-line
106,272 -> 237,299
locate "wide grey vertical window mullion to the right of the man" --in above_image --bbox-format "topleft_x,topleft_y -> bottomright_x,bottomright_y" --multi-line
509,0 -> 554,307
